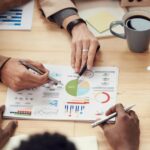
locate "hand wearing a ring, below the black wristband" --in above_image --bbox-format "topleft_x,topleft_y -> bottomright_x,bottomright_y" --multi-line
71,23 -> 99,72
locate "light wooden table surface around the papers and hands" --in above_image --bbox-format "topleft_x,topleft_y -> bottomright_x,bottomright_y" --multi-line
0,3 -> 150,150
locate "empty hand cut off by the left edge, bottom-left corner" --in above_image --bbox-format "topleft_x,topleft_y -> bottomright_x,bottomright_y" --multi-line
0,106 -> 18,149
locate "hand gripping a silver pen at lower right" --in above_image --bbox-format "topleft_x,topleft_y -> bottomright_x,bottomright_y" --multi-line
101,104 -> 140,150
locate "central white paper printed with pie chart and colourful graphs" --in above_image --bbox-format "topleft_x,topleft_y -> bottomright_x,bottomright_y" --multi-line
4,65 -> 118,121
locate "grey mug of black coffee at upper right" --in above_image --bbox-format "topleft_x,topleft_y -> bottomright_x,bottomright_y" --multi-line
110,10 -> 150,53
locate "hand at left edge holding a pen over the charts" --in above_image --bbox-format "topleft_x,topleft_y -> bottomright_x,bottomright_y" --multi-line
1,58 -> 48,91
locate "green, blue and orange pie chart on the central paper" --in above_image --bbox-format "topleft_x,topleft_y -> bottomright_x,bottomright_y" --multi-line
65,79 -> 90,96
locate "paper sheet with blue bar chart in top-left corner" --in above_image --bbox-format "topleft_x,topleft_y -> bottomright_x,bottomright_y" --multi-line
0,0 -> 34,30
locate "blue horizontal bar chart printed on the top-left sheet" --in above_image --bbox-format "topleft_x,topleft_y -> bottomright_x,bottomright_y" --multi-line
0,8 -> 23,26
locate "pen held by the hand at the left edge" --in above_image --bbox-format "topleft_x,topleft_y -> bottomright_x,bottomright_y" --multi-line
19,60 -> 62,85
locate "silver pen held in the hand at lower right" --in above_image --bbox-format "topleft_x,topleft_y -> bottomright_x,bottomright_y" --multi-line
91,105 -> 135,128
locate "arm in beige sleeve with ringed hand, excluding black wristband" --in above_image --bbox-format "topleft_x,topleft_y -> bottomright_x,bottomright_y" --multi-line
40,0 -> 99,72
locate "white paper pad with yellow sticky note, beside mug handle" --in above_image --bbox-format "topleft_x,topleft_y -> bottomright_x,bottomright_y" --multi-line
77,0 -> 126,37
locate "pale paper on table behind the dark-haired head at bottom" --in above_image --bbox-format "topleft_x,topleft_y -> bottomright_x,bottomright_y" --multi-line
2,135 -> 98,150
